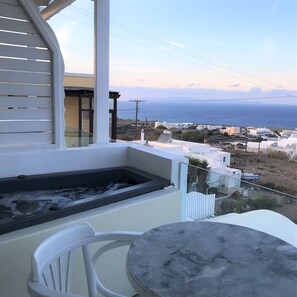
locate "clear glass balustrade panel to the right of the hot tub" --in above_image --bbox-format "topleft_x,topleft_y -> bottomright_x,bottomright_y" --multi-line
181,163 -> 297,223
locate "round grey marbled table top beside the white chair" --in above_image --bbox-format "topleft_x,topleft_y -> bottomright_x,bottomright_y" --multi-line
127,222 -> 297,297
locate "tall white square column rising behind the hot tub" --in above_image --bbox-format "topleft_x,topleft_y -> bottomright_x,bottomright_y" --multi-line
94,0 -> 110,144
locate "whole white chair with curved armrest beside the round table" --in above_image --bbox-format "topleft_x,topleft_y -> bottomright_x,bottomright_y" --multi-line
27,223 -> 141,297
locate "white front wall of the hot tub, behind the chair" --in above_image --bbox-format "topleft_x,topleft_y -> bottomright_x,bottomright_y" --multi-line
0,188 -> 181,297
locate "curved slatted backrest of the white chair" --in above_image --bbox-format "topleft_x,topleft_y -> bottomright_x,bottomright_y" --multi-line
31,223 -> 95,293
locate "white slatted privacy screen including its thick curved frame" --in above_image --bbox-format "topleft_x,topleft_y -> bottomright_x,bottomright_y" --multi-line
0,0 -> 64,148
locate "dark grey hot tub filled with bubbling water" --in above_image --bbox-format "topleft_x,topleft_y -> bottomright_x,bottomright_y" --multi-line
0,167 -> 170,234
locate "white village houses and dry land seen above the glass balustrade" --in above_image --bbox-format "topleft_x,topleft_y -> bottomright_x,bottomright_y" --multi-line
117,120 -> 297,204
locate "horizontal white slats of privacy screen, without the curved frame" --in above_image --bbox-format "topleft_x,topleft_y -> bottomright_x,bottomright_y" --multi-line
0,0 -> 54,147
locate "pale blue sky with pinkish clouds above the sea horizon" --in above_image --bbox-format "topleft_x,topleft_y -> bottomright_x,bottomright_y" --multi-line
49,0 -> 297,104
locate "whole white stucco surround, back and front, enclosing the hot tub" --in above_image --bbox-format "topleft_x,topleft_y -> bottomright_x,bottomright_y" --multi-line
0,143 -> 186,297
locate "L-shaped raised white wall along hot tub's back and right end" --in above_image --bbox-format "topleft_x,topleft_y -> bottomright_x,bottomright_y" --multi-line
0,142 -> 186,180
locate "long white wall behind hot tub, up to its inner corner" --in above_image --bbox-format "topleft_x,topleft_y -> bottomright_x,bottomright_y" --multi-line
0,144 -> 128,178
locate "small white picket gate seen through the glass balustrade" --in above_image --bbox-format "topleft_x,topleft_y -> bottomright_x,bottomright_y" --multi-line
186,192 -> 215,221
